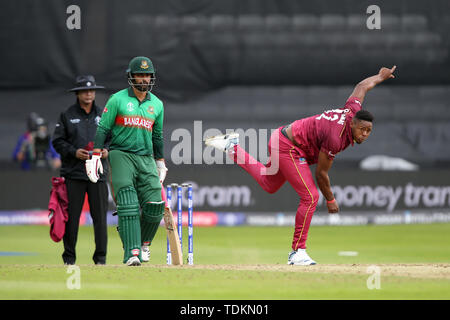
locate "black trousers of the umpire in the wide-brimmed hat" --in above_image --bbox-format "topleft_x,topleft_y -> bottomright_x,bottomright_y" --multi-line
62,178 -> 108,264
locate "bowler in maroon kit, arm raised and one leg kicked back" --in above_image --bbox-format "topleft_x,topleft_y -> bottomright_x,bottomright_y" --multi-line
206,66 -> 396,265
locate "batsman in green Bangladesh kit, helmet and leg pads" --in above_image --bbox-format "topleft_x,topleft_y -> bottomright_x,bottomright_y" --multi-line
86,56 -> 167,266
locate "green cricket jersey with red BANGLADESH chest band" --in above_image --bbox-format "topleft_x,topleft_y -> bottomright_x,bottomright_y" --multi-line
94,87 -> 164,159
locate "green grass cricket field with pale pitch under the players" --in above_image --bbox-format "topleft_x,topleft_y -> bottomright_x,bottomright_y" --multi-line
0,224 -> 450,300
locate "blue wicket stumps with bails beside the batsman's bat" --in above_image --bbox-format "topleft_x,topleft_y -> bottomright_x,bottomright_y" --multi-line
167,183 -> 194,265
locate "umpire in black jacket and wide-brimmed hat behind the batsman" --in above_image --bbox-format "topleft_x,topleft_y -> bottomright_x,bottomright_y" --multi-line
53,75 -> 110,265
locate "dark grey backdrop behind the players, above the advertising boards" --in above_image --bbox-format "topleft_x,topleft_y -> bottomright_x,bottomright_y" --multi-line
0,0 -> 450,211
